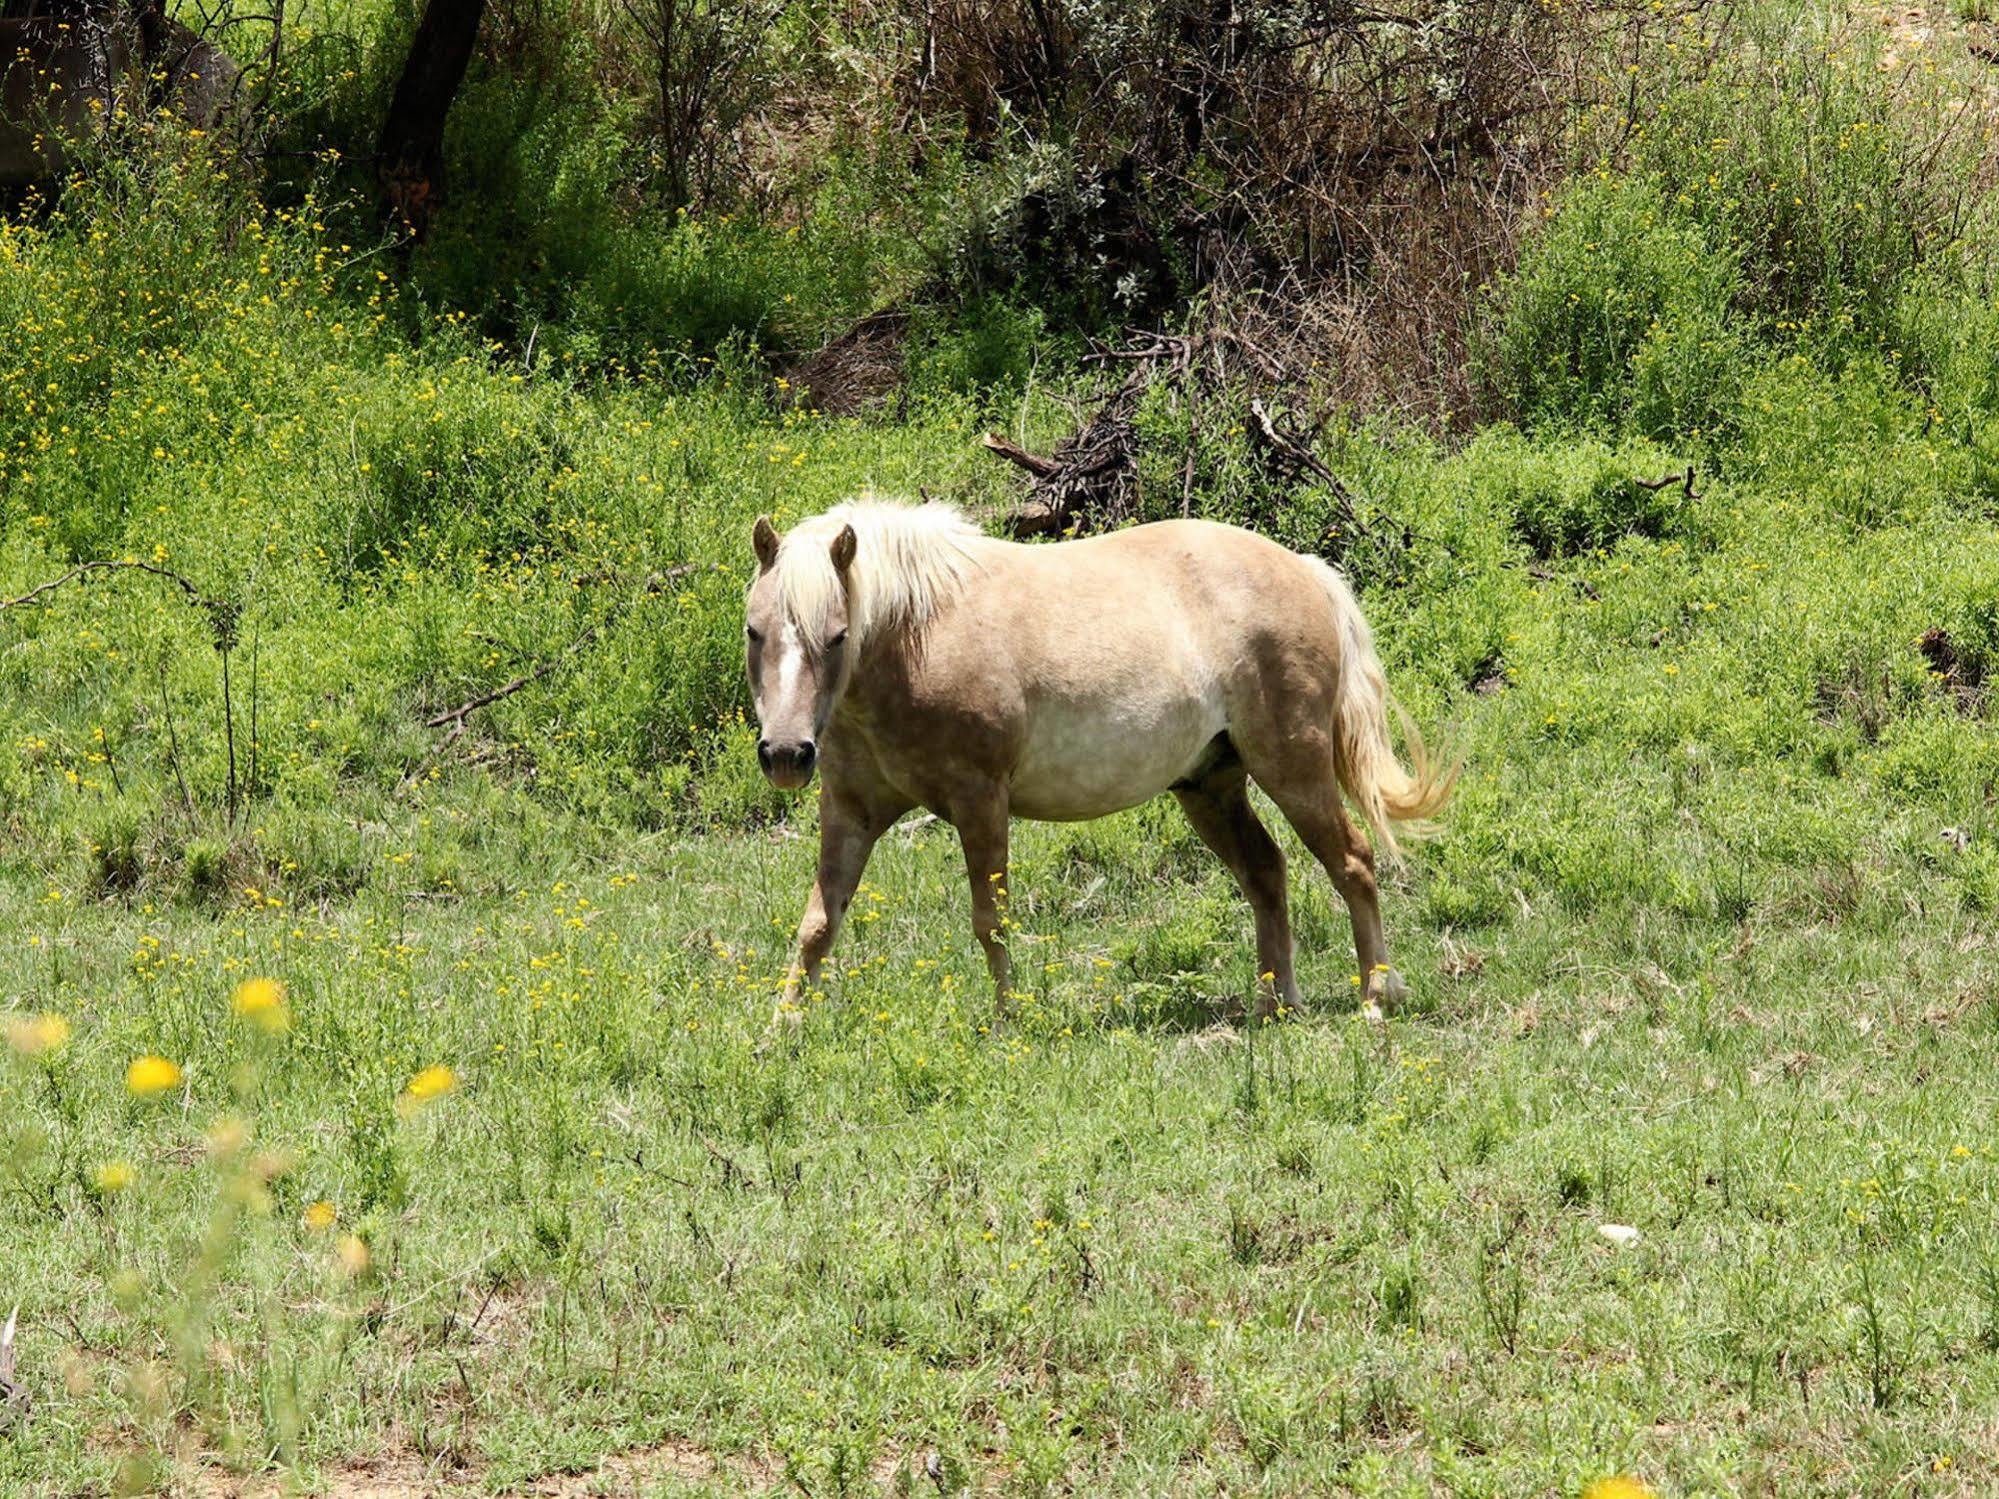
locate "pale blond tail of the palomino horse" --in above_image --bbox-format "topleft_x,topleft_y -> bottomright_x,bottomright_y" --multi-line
1317,562 -> 1457,857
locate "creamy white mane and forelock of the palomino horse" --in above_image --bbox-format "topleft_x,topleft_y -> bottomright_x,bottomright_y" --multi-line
772,500 -> 980,646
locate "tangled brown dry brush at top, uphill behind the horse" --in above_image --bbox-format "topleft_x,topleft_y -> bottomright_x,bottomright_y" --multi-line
851,0 -> 1643,426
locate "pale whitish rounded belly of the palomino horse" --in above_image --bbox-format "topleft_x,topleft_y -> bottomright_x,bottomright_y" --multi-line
1007,696 -> 1227,821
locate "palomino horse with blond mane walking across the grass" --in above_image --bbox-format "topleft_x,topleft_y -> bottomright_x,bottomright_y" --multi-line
746,502 -> 1455,1023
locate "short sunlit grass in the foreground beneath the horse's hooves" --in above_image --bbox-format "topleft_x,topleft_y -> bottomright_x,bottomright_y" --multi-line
0,787 -> 1999,1495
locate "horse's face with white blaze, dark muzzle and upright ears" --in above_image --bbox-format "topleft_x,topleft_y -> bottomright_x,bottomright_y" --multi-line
744,520 -> 854,791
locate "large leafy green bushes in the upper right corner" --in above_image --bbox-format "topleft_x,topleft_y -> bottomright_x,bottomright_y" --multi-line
1479,6 -> 1995,457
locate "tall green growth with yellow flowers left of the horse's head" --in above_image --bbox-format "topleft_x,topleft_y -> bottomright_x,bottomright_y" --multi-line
0,134 -> 995,847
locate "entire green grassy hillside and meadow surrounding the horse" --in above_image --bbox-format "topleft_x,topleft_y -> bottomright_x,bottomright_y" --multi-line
11,4 -> 1999,1499
